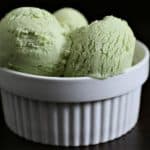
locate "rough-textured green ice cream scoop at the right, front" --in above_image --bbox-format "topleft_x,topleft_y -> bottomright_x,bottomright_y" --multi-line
65,16 -> 135,78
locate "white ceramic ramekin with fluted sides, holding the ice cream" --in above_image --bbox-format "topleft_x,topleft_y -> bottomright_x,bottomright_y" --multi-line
0,41 -> 149,146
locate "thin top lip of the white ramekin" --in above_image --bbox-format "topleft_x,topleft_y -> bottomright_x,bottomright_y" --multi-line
0,40 -> 150,81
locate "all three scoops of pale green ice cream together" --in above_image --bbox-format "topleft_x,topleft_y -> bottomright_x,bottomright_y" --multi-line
0,7 -> 135,79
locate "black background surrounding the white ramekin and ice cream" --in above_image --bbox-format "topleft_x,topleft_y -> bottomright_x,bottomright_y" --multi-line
0,0 -> 150,150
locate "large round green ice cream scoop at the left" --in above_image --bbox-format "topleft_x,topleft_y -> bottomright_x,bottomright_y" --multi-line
0,7 -> 67,76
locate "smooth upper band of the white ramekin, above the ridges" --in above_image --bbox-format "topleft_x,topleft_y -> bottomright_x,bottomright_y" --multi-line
0,42 -> 149,103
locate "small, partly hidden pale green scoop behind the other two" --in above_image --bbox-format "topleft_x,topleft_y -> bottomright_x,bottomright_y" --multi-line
54,8 -> 88,31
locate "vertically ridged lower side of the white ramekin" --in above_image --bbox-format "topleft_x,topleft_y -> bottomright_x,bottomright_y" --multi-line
1,88 -> 141,146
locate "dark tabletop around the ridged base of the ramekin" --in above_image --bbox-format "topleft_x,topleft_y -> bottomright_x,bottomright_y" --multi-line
0,79 -> 150,150
